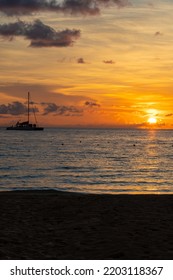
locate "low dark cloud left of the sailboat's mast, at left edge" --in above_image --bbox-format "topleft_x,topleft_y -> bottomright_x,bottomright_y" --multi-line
0,101 -> 27,115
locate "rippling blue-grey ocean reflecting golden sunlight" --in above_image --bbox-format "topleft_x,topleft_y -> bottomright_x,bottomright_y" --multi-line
0,128 -> 173,194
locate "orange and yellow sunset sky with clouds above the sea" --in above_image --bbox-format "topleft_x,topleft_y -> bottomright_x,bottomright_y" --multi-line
0,0 -> 173,129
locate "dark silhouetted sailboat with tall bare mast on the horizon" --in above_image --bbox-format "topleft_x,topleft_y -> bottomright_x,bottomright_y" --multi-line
6,92 -> 44,131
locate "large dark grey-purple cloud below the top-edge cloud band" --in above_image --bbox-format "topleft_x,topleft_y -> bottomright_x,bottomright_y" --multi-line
0,19 -> 80,47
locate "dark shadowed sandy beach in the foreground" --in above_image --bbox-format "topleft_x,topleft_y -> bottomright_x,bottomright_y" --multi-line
0,191 -> 173,260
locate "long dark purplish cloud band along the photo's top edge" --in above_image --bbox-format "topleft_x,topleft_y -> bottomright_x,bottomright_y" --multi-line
0,0 -> 129,16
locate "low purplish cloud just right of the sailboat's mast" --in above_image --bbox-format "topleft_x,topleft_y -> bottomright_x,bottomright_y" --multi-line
42,103 -> 83,116
